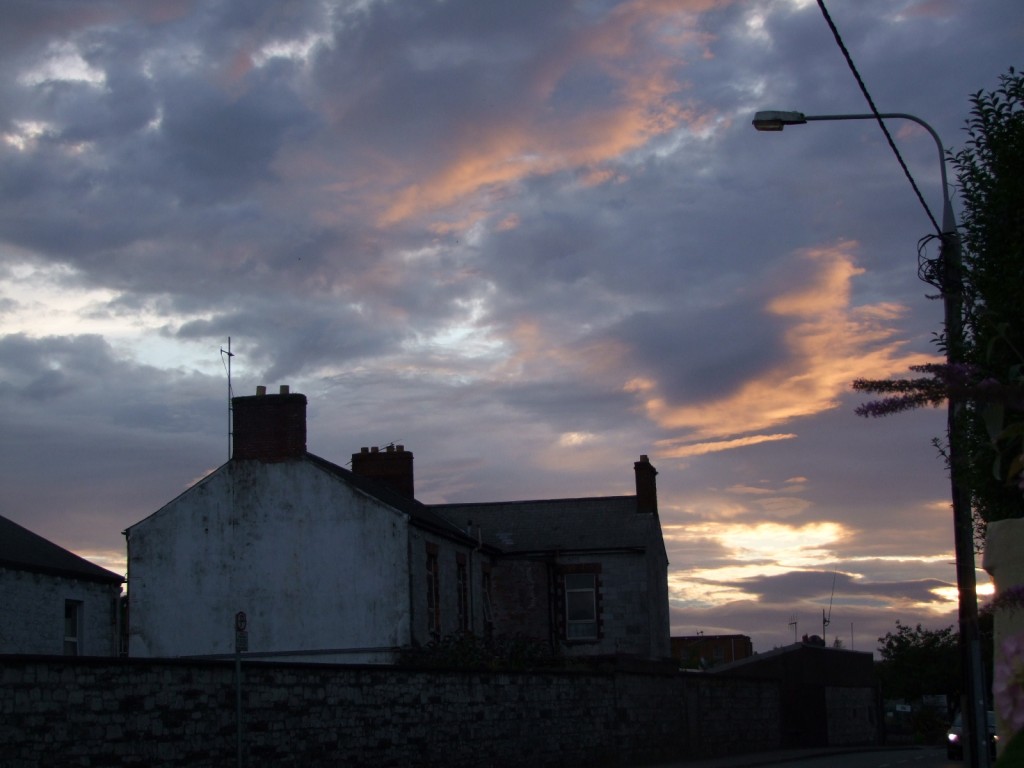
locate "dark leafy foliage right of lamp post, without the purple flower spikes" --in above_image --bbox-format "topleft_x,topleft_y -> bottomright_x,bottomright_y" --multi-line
952,69 -> 1024,522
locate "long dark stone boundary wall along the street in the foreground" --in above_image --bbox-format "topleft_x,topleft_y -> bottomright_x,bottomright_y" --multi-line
0,656 -> 779,768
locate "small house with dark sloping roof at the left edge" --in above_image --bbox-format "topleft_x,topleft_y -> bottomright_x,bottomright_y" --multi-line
0,517 -> 125,656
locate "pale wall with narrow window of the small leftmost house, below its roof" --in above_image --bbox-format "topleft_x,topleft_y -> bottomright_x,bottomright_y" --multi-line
0,567 -> 121,656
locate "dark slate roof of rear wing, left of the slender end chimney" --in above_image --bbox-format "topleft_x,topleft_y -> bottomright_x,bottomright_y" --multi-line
430,496 -> 656,554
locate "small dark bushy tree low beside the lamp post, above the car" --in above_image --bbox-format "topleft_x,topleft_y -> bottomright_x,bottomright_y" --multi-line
878,621 -> 961,702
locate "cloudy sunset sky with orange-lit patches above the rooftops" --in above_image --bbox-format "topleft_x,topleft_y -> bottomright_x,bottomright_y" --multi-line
0,0 -> 1024,652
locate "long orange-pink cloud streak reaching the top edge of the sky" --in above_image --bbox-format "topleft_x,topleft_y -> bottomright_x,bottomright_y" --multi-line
379,0 -> 723,225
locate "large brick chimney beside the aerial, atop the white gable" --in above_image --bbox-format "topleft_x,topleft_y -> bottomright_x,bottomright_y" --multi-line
231,384 -> 306,462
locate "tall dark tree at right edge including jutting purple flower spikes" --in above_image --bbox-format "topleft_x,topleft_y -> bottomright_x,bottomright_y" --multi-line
853,68 -> 1024,527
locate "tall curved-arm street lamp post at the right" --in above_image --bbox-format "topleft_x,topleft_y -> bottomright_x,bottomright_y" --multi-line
753,111 -> 989,768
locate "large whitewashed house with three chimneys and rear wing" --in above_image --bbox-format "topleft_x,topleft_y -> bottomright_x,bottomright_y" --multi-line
125,387 -> 669,663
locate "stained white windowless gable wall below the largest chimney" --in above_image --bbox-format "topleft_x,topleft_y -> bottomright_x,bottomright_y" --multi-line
128,460 -> 410,662
